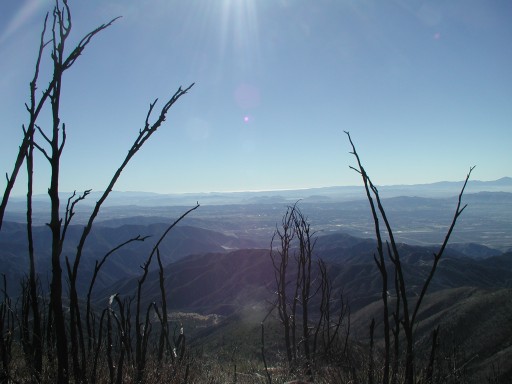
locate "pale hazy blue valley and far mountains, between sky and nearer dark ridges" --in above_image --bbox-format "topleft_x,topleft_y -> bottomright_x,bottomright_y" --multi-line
5,177 -> 512,251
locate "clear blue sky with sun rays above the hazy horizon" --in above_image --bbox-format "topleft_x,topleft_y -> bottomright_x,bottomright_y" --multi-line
0,0 -> 512,194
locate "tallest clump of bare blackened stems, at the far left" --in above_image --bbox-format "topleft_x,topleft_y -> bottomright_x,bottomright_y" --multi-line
0,0 -> 197,383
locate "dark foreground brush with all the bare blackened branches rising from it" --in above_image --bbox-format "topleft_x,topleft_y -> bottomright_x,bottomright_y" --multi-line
0,0 -> 510,384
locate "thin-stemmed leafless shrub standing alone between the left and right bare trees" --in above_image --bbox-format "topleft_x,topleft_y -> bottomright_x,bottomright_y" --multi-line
267,203 -> 350,382
